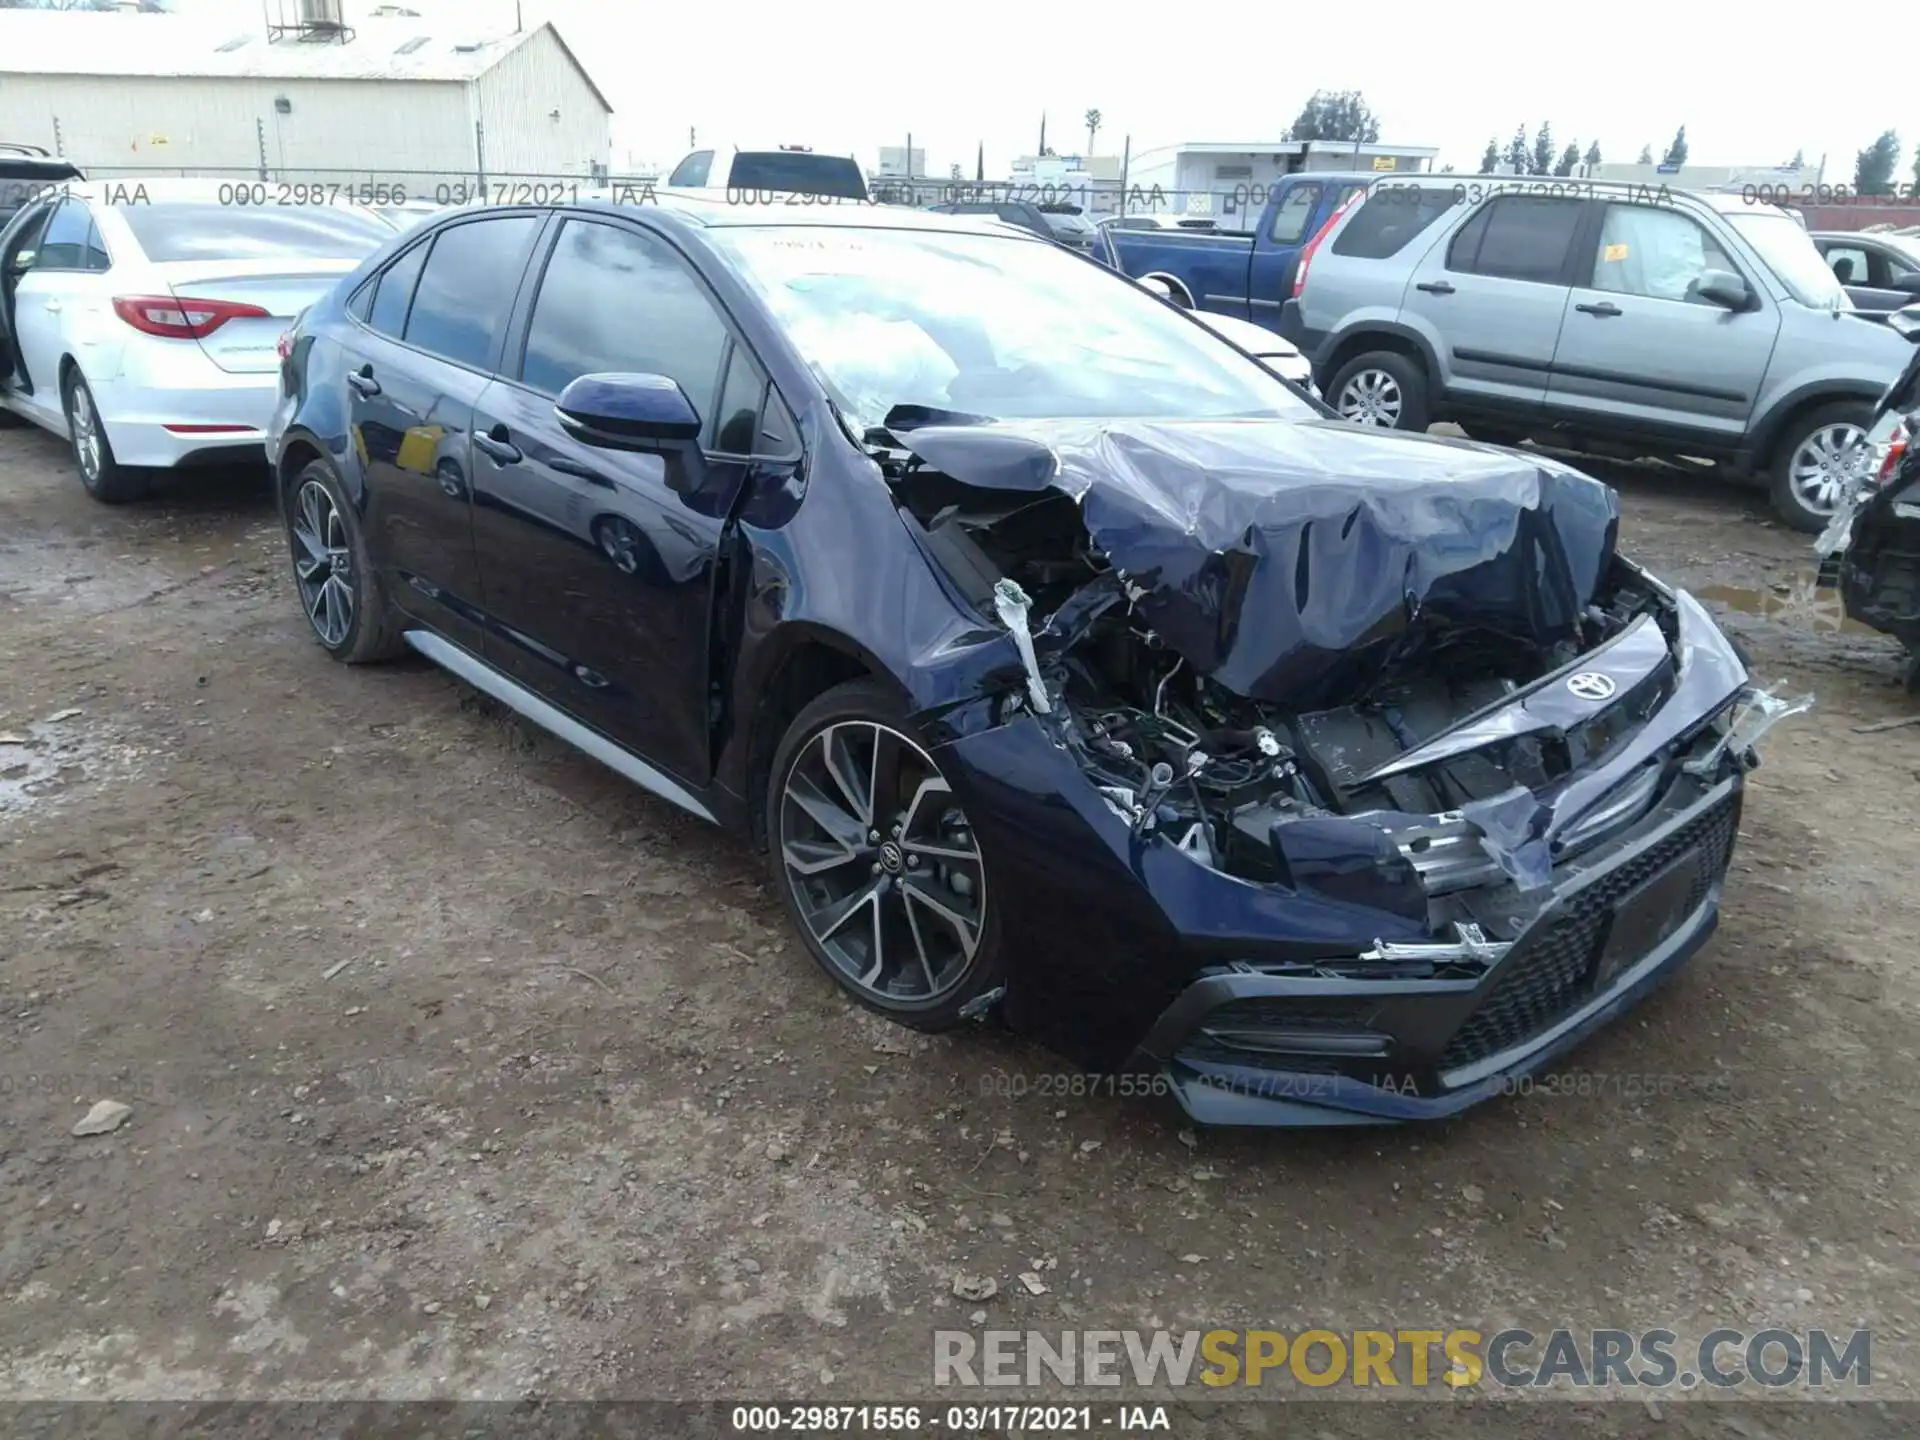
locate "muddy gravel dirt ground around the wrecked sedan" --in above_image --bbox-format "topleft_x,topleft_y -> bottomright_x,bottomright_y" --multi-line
0,430 -> 1920,1434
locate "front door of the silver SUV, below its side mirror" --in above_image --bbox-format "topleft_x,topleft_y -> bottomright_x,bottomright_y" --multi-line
1548,200 -> 1780,442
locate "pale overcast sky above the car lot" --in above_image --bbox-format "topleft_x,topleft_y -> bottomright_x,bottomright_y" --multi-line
191,0 -> 1920,182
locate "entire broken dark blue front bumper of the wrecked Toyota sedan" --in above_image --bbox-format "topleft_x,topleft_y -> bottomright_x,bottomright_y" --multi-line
937,593 -> 1811,1125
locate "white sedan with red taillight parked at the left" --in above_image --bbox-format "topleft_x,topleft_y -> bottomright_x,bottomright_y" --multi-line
0,180 -> 394,505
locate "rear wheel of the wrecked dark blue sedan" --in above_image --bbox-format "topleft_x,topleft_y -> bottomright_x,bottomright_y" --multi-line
284,461 -> 407,664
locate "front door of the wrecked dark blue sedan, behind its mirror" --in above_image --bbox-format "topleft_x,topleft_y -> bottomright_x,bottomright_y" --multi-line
474,217 -> 789,785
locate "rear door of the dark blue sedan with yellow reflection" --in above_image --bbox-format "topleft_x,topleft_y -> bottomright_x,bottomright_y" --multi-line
346,211 -> 541,655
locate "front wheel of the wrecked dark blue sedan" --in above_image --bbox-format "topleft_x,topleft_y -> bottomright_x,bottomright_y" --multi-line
766,680 -> 1004,1031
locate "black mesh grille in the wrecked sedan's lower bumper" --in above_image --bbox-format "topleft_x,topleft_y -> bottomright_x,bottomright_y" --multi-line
1440,795 -> 1740,1069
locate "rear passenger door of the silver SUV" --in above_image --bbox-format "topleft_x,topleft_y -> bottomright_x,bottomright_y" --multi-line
1397,194 -> 1588,411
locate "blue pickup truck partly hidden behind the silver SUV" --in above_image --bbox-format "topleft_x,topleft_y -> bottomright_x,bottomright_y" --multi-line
1100,171 -> 1394,330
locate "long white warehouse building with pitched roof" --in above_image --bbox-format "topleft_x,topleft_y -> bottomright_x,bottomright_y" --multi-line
0,6 -> 612,180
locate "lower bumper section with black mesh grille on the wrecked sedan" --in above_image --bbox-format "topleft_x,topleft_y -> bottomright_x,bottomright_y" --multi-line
1131,766 -> 1745,1125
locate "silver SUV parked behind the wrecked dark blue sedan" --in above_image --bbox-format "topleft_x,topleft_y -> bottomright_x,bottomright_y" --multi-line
1281,175 -> 1908,532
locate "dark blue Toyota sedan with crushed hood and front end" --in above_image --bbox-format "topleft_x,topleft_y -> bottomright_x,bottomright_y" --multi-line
271,194 -> 1795,1123
